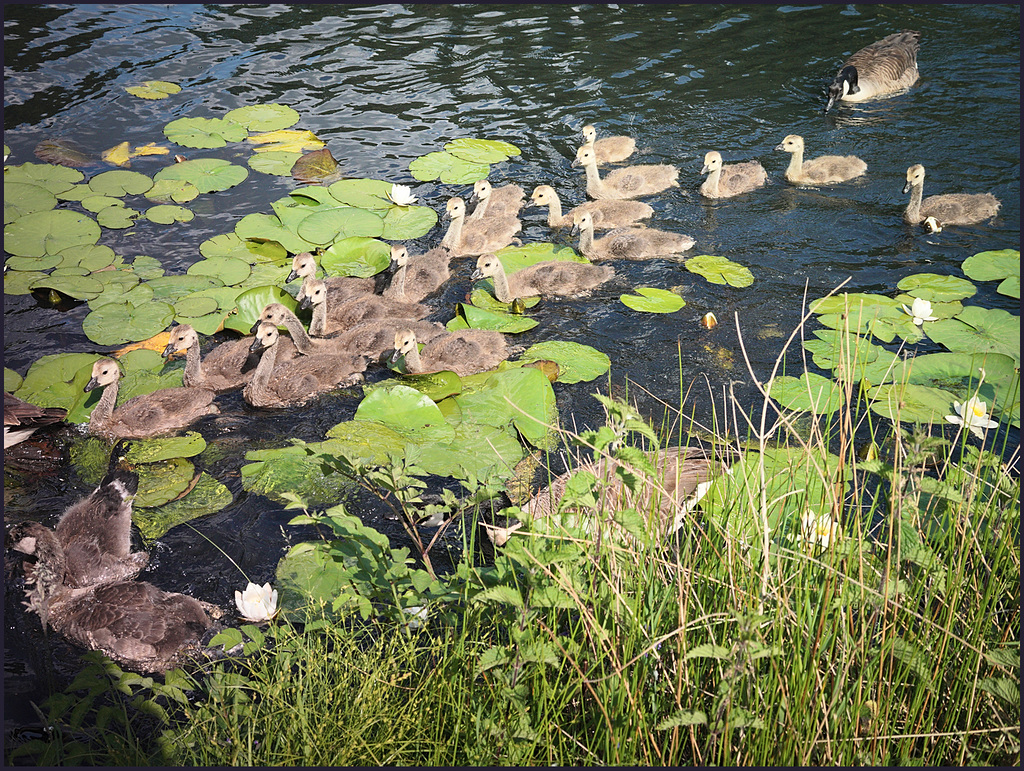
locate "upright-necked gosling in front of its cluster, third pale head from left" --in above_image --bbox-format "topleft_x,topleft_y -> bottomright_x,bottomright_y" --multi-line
242,322 -> 367,408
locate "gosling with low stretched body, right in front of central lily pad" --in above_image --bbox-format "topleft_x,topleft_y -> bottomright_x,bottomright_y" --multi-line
470,254 -> 615,302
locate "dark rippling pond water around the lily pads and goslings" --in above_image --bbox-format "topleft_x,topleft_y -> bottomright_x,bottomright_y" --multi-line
4,4 -> 1020,727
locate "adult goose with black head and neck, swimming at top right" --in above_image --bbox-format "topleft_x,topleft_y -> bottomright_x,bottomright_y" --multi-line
824,30 -> 921,113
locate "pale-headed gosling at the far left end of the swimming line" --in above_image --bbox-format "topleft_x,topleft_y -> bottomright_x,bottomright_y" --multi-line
84,358 -> 220,439
